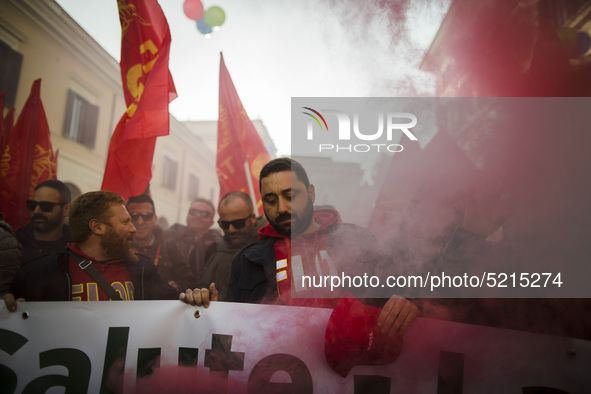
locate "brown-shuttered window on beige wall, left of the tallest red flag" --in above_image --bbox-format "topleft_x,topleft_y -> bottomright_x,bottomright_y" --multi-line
64,90 -> 98,149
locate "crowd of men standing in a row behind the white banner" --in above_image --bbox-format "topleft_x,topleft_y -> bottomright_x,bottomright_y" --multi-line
0,158 -> 418,333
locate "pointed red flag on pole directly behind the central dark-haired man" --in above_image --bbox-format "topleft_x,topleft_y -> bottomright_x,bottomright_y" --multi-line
216,54 -> 271,214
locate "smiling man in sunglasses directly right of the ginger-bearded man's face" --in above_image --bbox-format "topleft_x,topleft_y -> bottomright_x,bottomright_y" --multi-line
126,194 -> 197,290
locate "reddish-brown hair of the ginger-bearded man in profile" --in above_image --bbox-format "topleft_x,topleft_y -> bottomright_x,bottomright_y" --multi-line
70,190 -> 125,243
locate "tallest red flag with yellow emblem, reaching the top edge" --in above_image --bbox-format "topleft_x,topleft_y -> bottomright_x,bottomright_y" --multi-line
101,0 -> 177,199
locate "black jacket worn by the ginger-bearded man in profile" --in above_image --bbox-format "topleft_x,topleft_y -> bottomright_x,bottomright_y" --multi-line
11,253 -> 178,301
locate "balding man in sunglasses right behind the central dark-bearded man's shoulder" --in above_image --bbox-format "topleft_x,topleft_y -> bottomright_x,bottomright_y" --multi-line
199,191 -> 259,299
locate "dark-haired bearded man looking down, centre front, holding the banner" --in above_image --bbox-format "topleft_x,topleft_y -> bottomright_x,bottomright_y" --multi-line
180,158 -> 419,336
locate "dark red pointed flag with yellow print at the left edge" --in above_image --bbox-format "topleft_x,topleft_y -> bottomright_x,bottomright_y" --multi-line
0,79 -> 57,229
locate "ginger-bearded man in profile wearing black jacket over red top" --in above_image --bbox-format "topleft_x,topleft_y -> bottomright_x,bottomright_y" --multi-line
2,191 -> 178,311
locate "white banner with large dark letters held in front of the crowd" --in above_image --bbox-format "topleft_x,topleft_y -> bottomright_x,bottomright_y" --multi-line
0,301 -> 591,394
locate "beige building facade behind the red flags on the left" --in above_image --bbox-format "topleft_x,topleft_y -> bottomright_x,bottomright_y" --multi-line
0,0 -> 219,225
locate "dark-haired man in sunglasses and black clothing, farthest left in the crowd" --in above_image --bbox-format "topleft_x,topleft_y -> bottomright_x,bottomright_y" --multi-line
16,179 -> 72,263
